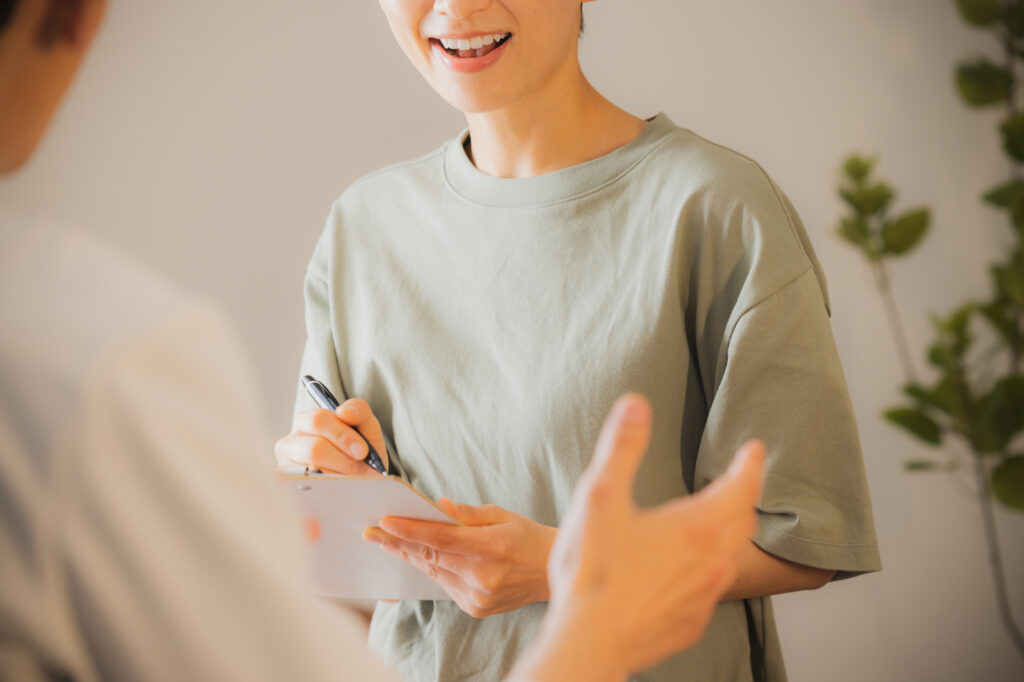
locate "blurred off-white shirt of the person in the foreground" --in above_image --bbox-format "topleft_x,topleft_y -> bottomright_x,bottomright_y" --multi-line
0,214 -> 392,680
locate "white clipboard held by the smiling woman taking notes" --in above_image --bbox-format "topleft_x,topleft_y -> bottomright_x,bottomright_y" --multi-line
279,467 -> 461,601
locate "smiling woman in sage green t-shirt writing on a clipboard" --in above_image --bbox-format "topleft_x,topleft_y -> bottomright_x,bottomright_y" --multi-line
278,0 -> 879,680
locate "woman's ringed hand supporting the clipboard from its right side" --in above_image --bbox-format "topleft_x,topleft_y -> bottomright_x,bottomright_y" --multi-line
364,498 -> 558,619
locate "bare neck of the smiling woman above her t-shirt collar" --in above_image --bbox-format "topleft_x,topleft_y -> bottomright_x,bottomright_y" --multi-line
466,71 -> 646,177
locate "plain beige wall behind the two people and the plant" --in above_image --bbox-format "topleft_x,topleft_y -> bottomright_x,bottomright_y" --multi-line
0,0 -> 1024,681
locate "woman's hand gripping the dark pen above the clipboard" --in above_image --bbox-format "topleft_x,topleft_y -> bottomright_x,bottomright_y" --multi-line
273,398 -> 391,475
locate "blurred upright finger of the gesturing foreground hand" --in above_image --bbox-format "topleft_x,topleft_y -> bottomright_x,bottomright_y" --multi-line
585,393 -> 651,496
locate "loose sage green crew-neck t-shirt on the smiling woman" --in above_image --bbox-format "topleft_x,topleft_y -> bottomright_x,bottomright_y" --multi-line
297,114 -> 880,682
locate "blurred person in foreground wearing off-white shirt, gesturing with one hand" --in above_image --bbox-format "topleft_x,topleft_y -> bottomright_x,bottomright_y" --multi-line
0,0 -> 764,680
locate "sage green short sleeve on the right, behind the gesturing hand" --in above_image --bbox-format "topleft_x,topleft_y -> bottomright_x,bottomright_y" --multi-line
694,266 -> 881,578
